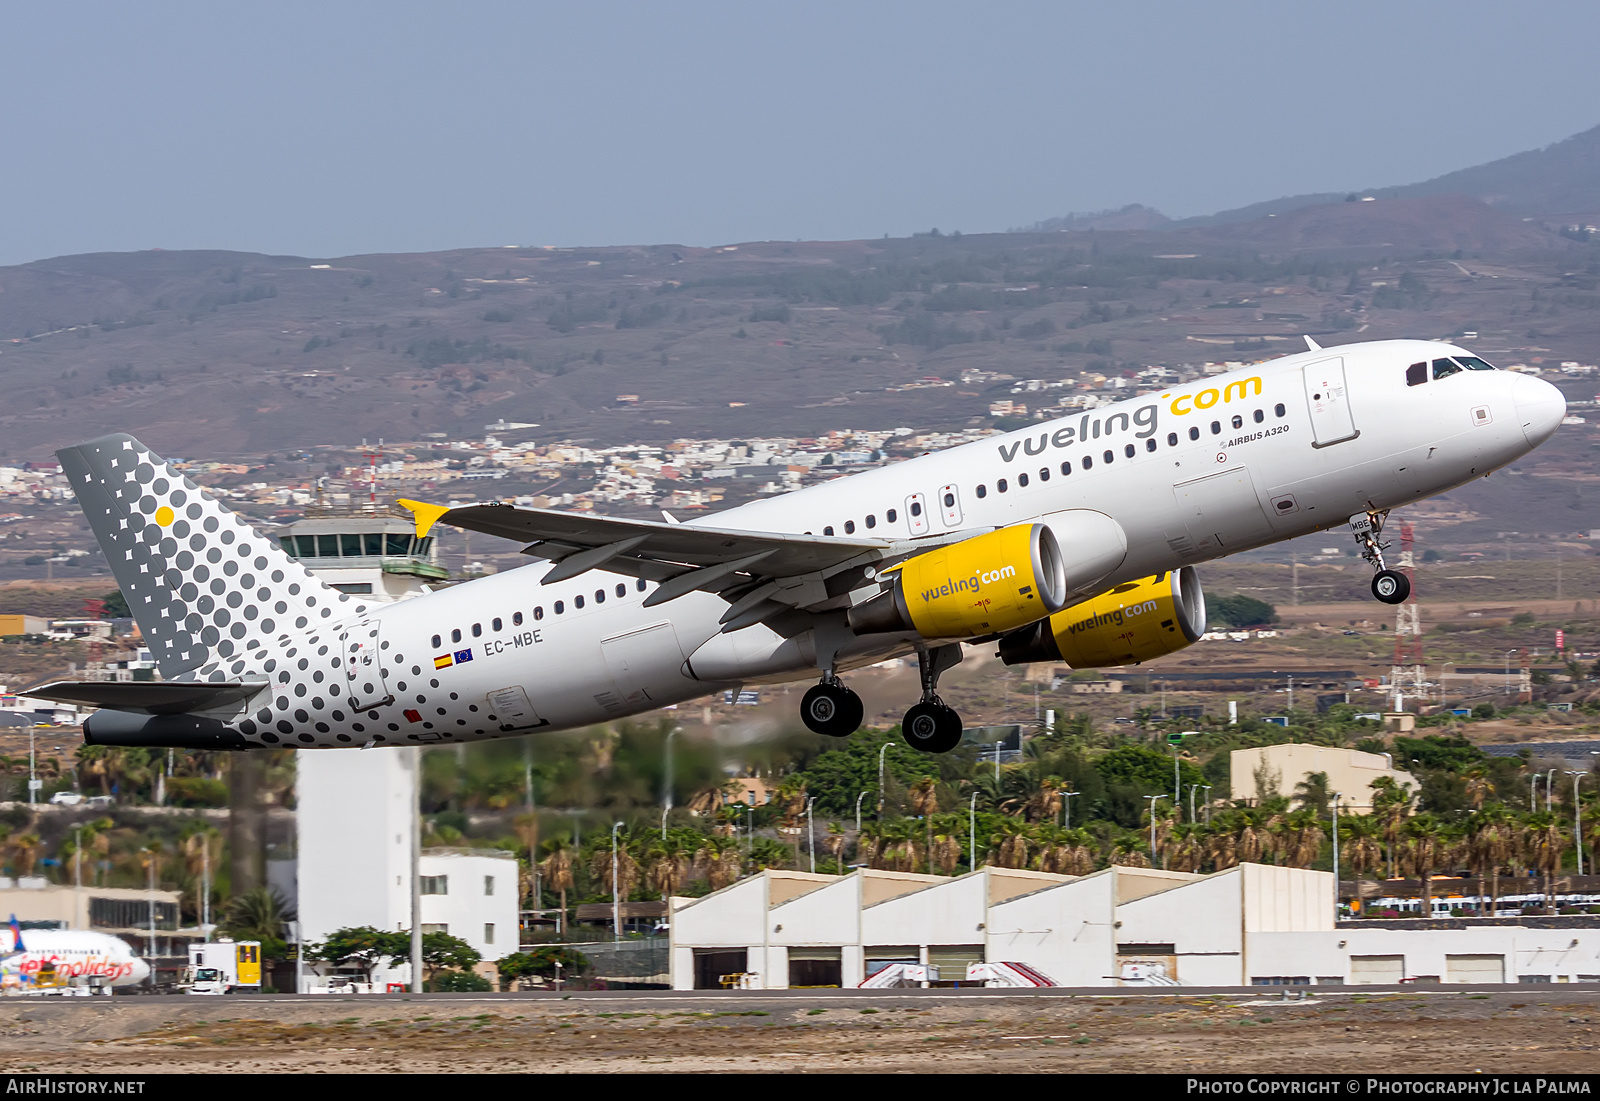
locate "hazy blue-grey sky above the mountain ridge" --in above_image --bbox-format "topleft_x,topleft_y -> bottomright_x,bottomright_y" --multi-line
0,0 -> 1600,264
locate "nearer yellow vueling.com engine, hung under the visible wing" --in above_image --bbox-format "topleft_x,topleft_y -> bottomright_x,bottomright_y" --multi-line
850,523 -> 1067,639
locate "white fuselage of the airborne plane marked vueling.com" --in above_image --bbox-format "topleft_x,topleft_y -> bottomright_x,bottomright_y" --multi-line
219,341 -> 1565,746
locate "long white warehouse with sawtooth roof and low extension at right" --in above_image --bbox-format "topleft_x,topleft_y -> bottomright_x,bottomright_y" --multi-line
670,864 -> 1600,989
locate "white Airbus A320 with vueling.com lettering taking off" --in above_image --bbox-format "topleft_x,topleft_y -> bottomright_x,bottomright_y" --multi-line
30,339 -> 1566,752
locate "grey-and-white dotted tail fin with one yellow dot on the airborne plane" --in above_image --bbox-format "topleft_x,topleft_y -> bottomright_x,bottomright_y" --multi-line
56,434 -> 366,680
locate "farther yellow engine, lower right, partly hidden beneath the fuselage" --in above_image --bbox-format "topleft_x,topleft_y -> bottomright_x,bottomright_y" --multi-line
1000,567 -> 1205,669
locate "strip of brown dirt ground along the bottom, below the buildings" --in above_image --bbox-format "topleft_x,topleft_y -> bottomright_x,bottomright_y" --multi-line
0,986 -> 1600,1074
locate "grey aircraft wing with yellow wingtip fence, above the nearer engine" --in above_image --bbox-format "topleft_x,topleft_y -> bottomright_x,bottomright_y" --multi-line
400,501 -> 987,632
